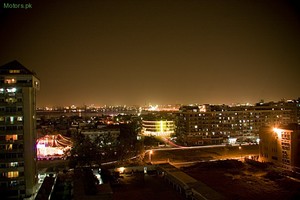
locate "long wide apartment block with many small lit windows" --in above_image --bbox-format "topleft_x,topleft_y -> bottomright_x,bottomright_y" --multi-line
176,100 -> 300,145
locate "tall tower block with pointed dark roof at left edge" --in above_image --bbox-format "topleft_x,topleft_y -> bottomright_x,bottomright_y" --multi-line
0,61 -> 40,199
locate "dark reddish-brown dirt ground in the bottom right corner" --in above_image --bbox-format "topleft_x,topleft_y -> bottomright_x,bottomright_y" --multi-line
182,160 -> 300,200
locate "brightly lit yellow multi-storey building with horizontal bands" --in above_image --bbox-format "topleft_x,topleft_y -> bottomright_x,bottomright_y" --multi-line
142,120 -> 175,137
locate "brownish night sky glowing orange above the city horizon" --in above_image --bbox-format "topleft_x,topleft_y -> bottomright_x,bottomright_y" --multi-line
0,0 -> 300,106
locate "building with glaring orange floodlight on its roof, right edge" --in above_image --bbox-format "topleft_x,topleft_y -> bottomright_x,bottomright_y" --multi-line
259,124 -> 300,171
